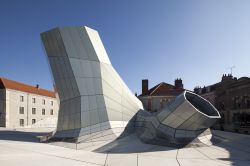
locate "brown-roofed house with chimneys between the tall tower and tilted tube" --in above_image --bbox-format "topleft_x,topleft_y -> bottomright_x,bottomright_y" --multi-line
138,79 -> 185,112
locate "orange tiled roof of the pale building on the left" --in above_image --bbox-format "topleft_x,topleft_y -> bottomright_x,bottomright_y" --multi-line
0,77 -> 55,98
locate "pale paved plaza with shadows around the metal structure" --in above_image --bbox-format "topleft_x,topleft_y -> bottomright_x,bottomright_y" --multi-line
0,130 -> 250,166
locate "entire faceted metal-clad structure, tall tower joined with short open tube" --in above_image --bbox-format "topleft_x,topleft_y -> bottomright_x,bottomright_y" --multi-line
41,26 -> 220,147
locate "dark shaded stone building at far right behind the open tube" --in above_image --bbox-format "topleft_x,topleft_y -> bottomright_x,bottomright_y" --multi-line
194,74 -> 250,133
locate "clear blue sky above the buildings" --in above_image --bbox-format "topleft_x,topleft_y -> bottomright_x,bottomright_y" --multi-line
0,0 -> 250,93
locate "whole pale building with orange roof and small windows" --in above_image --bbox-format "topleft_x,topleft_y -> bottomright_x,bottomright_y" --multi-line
0,78 -> 58,128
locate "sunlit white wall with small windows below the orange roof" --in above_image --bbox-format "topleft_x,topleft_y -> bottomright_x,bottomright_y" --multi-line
6,89 -> 58,128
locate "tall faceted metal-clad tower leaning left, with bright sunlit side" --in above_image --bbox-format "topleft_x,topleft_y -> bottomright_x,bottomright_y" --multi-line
41,26 -> 143,143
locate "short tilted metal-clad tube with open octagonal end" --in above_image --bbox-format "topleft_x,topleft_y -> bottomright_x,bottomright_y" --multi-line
137,91 -> 220,147
